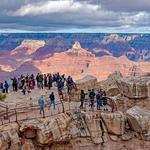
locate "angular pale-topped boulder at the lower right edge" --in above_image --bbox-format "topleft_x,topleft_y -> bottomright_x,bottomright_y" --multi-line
126,106 -> 150,140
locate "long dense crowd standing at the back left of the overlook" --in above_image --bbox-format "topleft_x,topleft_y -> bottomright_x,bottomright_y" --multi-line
0,73 -> 74,95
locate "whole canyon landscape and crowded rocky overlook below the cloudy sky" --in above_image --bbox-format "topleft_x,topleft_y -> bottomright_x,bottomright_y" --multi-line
0,34 -> 150,150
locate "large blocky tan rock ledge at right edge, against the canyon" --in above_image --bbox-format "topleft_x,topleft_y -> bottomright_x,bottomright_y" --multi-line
117,77 -> 150,99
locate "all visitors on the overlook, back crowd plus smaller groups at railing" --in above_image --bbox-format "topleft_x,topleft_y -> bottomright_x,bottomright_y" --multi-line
0,73 -> 108,117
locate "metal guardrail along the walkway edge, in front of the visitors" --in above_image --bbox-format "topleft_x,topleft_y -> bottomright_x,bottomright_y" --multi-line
0,96 -> 117,126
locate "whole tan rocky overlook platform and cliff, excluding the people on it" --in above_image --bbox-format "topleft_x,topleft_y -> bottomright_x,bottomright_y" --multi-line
0,72 -> 150,150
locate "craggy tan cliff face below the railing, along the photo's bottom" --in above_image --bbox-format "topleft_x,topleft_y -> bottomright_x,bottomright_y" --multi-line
0,108 -> 150,150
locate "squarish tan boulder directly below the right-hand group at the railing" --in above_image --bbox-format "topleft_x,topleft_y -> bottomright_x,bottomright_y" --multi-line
101,111 -> 125,135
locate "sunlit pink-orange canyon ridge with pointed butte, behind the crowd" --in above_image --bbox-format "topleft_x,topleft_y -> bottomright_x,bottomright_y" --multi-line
0,40 -> 150,80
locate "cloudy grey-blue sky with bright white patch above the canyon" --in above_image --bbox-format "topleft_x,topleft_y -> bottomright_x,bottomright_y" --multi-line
0,0 -> 150,33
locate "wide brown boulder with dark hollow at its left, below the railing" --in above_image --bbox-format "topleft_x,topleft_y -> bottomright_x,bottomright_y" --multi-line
20,114 -> 71,145
